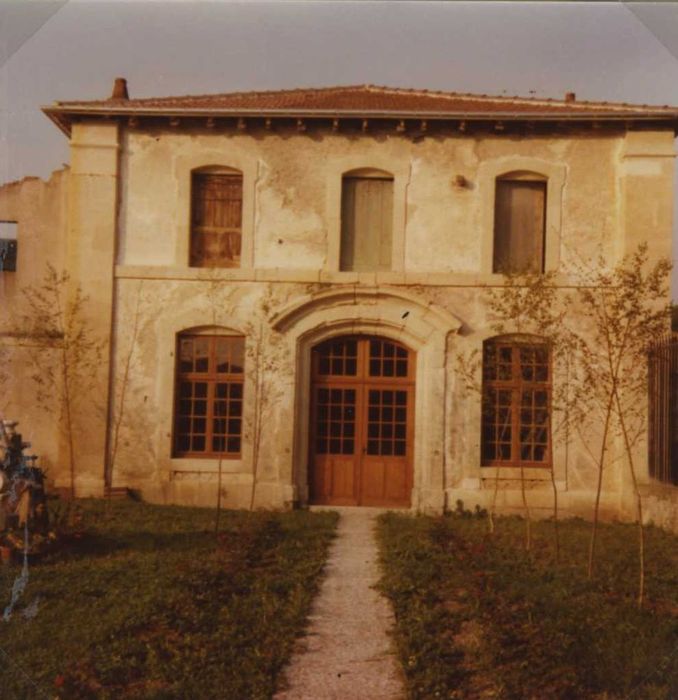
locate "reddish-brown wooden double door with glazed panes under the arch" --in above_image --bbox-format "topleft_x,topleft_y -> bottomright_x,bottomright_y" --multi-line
309,336 -> 415,507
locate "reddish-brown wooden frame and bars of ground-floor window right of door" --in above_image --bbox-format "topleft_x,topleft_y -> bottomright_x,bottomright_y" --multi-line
480,337 -> 553,469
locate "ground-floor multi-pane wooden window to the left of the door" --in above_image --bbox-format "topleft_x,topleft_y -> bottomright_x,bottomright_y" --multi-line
173,333 -> 245,458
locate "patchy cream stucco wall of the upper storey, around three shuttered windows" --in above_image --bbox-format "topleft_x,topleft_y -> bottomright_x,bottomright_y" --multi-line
118,131 -> 624,273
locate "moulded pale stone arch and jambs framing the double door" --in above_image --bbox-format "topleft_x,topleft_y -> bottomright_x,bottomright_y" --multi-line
270,286 -> 462,512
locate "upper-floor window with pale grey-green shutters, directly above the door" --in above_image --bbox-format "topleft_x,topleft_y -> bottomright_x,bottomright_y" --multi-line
339,168 -> 393,272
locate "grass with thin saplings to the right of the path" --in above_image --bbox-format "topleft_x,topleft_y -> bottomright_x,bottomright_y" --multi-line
379,514 -> 678,700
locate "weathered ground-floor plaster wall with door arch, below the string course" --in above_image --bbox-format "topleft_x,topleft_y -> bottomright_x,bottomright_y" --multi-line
109,277 -> 620,517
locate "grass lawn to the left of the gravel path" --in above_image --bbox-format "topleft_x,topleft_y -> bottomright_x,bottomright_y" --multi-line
0,501 -> 336,700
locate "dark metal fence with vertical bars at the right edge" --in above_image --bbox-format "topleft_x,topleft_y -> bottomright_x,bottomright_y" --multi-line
648,333 -> 678,485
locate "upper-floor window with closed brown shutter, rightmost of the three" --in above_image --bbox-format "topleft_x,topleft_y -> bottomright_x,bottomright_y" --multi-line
492,172 -> 547,274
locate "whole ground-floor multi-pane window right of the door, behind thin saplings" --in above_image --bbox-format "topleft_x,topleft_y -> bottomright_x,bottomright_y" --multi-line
481,335 -> 551,467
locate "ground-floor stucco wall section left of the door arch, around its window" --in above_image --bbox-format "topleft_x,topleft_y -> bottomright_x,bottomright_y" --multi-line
111,280 -> 303,507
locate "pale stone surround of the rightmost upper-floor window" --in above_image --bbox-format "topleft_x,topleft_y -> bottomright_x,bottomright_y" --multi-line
478,156 -> 567,279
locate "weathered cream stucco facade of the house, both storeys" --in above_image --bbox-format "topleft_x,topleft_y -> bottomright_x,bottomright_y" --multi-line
0,123 -> 675,524
